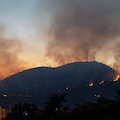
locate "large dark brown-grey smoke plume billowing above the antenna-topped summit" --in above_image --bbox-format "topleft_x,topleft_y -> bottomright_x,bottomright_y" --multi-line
46,0 -> 120,69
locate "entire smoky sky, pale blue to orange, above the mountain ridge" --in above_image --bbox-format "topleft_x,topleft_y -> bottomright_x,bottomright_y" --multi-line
0,0 -> 120,80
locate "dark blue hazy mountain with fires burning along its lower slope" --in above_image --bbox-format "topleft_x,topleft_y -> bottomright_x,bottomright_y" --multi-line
0,61 -> 119,106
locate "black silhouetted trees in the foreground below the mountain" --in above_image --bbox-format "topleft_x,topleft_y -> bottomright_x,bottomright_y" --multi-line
5,89 -> 120,120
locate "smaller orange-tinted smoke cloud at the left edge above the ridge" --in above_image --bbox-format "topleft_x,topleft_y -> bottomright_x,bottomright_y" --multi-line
0,25 -> 25,80
